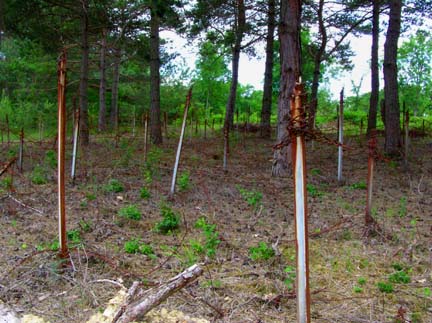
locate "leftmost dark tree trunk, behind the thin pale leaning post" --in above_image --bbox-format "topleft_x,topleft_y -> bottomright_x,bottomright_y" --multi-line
79,0 -> 90,146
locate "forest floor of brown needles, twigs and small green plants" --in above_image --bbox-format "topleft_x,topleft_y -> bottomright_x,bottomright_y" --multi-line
0,128 -> 432,323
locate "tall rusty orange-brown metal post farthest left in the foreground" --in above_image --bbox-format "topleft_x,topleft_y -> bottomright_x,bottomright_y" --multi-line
57,51 -> 69,259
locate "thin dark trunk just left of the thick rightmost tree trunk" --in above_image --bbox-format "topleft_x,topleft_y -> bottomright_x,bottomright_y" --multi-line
367,0 -> 380,136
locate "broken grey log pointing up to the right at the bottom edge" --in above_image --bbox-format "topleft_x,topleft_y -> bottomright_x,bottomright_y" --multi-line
113,264 -> 203,323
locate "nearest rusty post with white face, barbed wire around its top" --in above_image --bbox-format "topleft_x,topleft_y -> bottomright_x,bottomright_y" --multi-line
291,83 -> 311,323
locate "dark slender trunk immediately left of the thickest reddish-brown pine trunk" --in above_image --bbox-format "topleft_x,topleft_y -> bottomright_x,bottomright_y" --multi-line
261,0 -> 276,138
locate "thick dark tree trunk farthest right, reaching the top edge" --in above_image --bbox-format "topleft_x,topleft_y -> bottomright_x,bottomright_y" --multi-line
384,0 -> 402,155
